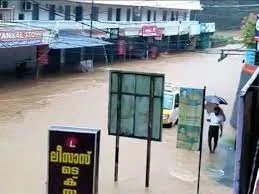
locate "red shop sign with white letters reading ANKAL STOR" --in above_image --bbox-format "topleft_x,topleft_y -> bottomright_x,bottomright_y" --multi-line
0,30 -> 45,41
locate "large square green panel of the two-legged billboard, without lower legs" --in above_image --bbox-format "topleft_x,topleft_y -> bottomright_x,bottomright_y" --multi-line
108,71 -> 164,141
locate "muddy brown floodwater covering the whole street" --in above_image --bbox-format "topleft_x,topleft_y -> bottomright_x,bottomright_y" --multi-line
0,47 -> 242,194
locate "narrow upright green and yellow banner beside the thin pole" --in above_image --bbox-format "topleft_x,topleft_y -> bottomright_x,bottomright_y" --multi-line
176,88 -> 204,151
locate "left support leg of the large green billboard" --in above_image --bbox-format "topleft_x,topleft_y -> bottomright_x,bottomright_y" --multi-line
114,74 -> 122,182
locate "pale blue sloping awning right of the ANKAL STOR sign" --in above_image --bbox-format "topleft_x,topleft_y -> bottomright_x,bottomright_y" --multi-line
49,34 -> 112,49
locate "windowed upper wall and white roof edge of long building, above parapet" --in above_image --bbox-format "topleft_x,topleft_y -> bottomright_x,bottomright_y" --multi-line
8,0 -> 197,22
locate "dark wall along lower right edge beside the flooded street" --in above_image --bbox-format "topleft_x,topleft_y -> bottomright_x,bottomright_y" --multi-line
239,78 -> 259,194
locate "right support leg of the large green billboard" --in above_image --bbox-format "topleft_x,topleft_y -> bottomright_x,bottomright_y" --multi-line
146,78 -> 154,188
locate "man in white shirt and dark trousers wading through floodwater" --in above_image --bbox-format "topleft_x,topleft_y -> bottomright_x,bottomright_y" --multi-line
207,107 -> 224,153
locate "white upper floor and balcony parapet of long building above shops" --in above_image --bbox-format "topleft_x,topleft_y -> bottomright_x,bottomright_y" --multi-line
0,0 -> 215,36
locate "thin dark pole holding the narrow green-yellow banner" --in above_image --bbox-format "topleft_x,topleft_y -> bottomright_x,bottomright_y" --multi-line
197,87 -> 206,194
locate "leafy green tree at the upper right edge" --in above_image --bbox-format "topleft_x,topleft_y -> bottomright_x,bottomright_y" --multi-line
241,13 -> 256,48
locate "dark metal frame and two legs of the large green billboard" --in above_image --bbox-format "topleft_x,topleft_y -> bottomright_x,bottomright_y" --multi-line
108,70 -> 165,187
